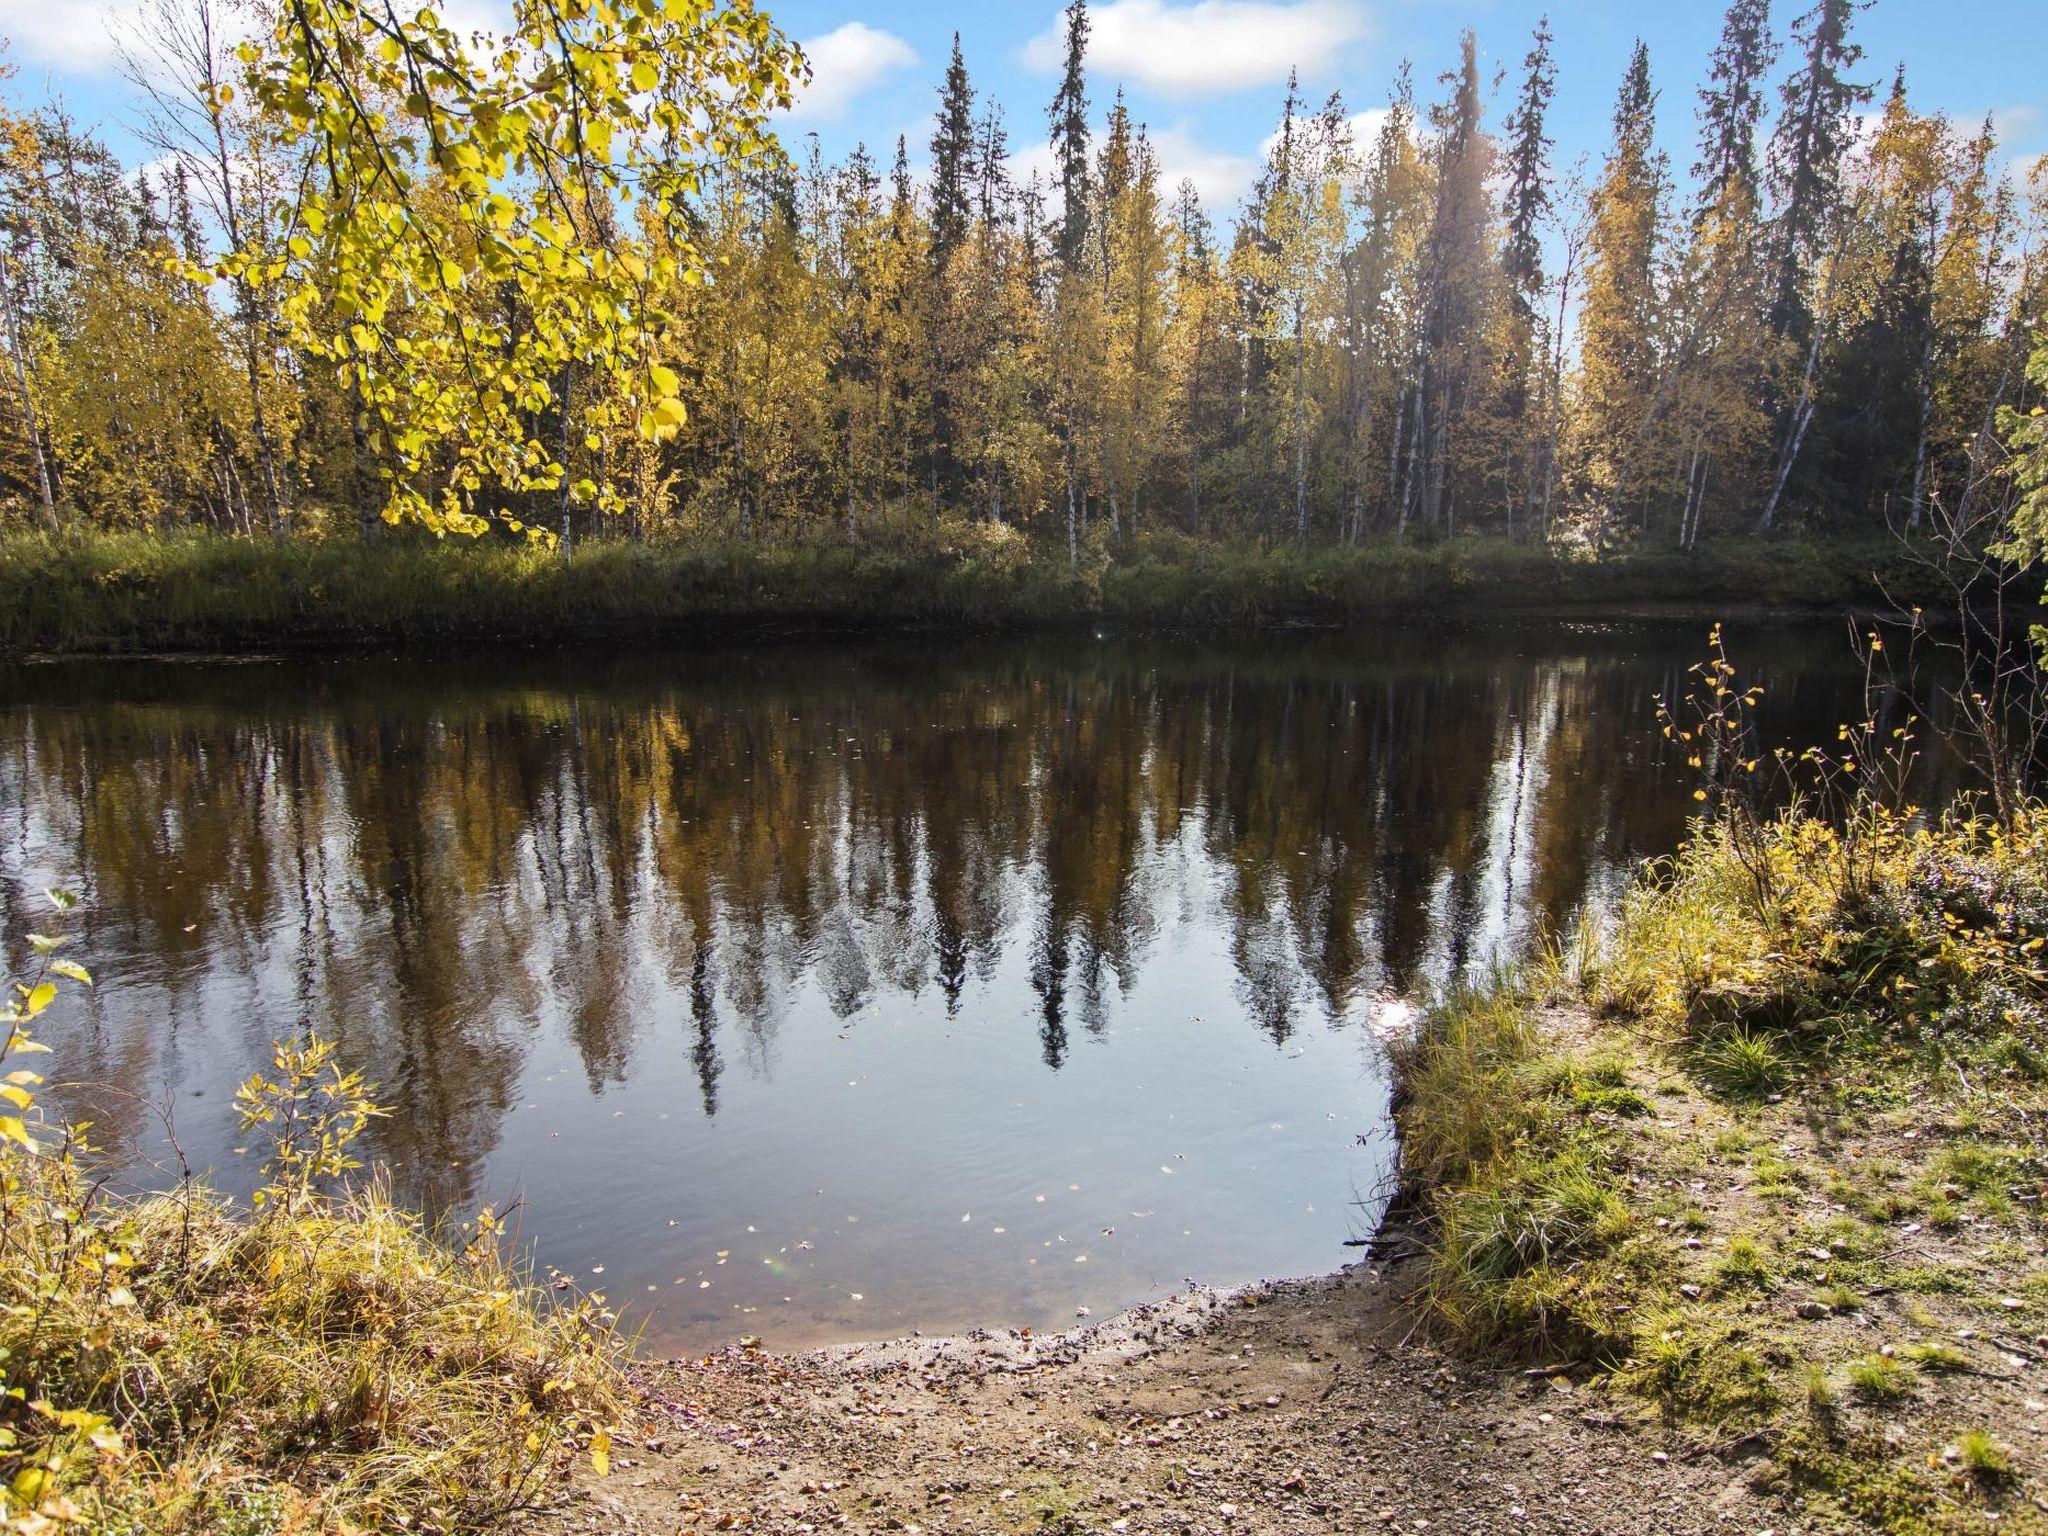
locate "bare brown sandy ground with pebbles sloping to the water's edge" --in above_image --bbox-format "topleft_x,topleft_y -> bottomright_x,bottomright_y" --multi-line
528,1266 -> 1819,1536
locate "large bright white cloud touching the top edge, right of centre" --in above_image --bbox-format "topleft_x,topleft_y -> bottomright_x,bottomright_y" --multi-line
1024,0 -> 1366,94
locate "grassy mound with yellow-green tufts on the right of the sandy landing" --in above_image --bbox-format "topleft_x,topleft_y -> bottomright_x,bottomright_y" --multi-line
1397,782 -> 2048,1536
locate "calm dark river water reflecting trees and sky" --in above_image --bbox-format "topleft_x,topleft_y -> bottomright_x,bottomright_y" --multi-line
0,627 -> 1949,1343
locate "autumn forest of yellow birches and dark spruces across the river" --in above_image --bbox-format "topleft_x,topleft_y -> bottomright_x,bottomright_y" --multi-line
0,0 -> 2048,561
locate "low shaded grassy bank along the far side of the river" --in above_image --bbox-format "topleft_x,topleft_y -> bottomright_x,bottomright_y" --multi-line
0,526 -> 1944,653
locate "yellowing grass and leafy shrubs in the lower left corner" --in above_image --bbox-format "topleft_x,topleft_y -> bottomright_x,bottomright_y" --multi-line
0,897 -> 621,1536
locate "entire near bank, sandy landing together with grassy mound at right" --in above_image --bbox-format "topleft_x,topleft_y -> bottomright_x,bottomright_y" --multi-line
547,794 -> 2048,1536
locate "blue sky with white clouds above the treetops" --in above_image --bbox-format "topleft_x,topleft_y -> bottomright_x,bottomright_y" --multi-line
0,0 -> 2048,211
